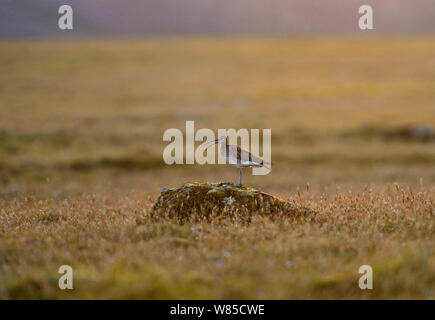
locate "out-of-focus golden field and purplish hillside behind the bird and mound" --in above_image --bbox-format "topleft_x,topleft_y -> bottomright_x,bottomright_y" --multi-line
0,0 -> 435,197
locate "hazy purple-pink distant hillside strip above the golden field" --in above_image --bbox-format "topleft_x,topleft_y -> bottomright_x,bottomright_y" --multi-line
0,0 -> 435,38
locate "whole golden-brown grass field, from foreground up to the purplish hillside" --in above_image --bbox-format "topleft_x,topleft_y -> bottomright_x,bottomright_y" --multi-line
0,36 -> 435,299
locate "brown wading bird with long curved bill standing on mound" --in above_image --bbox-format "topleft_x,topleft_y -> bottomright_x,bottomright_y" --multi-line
204,136 -> 272,187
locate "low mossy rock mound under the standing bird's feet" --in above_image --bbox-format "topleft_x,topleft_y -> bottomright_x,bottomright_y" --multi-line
152,182 -> 314,223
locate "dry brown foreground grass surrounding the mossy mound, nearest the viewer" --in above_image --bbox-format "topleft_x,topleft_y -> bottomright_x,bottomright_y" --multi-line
0,185 -> 435,299
